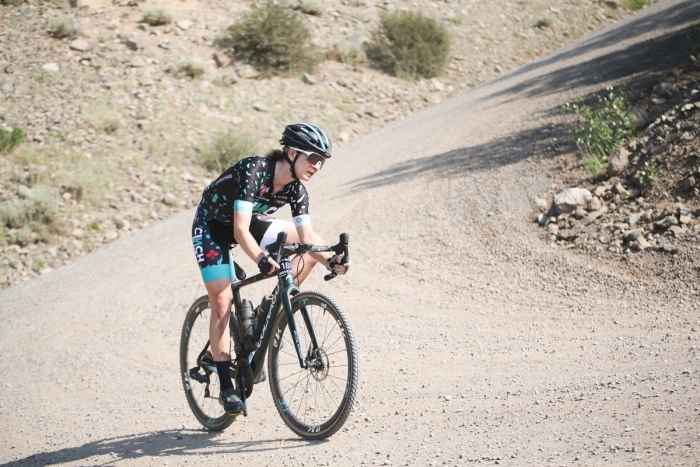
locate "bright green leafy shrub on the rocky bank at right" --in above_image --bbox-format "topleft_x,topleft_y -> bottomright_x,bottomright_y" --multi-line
564,86 -> 635,175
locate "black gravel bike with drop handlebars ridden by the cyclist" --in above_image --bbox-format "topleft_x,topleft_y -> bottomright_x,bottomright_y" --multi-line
180,232 -> 360,440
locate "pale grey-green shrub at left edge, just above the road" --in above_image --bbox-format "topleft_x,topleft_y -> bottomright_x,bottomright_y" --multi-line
0,186 -> 59,245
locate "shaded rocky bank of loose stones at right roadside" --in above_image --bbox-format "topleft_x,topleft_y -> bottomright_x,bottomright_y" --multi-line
535,65 -> 700,284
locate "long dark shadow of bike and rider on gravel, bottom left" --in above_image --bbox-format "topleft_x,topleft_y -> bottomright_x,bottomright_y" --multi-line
0,429 -> 319,466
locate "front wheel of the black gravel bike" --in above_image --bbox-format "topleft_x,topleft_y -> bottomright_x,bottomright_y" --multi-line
268,291 -> 360,439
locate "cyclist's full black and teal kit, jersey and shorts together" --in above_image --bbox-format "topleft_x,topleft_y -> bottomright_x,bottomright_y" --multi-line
192,156 -> 311,282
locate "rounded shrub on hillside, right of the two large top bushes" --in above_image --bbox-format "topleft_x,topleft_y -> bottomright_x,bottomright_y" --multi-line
367,11 -> 450,79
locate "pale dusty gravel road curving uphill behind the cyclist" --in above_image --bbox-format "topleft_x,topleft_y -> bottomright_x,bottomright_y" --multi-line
0,0 -> 700,466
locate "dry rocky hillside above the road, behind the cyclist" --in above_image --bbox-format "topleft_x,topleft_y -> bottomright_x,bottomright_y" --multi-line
0,0 -> 630,287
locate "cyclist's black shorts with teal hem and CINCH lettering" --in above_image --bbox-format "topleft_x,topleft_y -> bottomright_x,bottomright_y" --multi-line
192,209 -> 286,282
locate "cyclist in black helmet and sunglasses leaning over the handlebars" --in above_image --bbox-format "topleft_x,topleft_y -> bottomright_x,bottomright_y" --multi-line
192,123 -> 350,415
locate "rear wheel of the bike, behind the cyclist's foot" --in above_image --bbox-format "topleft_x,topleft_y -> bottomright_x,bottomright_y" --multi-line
180,295 -> 236,431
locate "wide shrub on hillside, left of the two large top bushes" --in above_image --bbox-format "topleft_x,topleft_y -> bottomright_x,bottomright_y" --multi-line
216,3 -> 320,75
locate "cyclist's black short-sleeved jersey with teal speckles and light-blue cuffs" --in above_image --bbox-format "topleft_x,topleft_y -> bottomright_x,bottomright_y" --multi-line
198,156 -> 311,226
